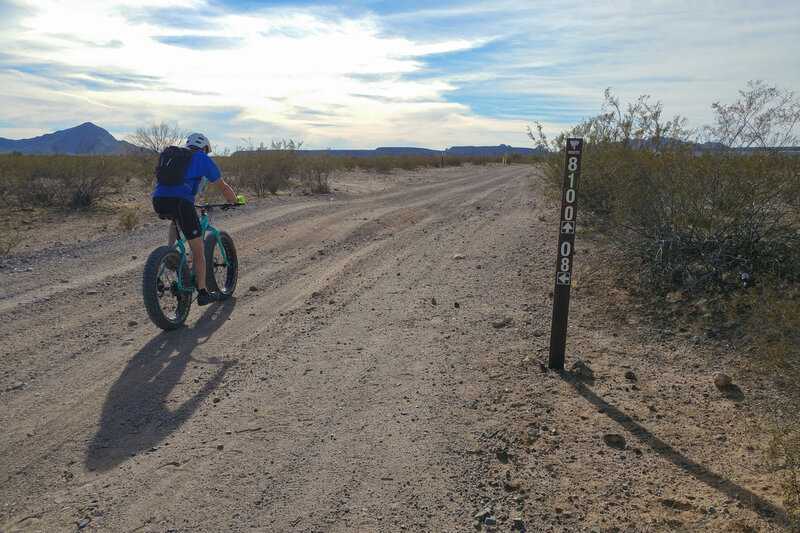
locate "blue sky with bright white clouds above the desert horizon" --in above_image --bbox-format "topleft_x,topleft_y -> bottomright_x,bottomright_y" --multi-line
0,0 -> 800,152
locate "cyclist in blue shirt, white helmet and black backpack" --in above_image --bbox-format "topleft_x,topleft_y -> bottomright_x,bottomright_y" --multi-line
153,133 -> 239,305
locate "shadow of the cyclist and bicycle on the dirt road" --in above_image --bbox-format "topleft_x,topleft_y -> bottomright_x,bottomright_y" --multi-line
86,299 -> 237,471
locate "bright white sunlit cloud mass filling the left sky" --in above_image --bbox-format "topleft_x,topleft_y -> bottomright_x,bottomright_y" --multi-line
2,1 -> 494,148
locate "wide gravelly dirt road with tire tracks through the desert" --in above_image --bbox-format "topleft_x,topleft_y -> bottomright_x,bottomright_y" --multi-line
0,166 -> 783,532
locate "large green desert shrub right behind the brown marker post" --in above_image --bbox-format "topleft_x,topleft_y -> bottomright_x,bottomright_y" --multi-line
536,83 -> 800,295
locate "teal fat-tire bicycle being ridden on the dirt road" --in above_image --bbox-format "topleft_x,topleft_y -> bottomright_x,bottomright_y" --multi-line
142,204 -> 241,331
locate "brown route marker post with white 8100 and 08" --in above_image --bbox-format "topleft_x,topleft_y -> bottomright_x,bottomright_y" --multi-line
548,139 -> 583,370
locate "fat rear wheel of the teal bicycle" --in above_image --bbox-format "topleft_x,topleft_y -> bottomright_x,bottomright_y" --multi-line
142,246 -> 192,331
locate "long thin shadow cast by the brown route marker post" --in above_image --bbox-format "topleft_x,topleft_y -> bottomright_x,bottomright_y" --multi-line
559,372 -> 786,521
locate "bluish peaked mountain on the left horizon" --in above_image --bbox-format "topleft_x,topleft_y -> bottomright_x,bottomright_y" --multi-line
0,122 -> 138,155
